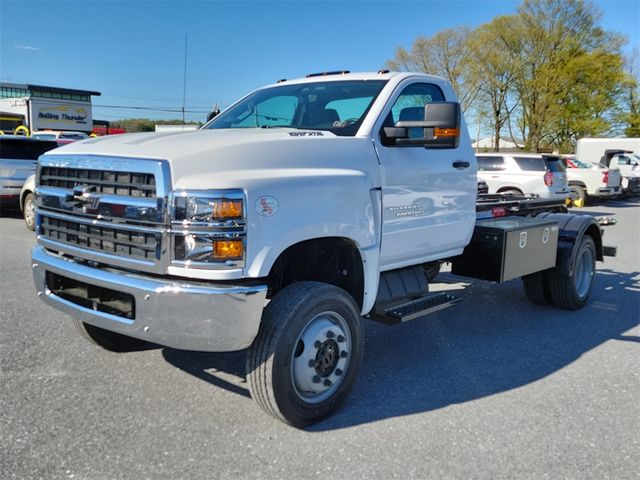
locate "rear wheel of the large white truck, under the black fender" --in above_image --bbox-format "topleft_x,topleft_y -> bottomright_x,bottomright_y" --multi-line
549,235 -> 596,310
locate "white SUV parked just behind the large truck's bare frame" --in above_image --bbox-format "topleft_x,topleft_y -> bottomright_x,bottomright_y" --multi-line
476,153 -> 571,199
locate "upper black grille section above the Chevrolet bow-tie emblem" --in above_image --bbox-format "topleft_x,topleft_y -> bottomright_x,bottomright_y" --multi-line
40,166 -> 156,198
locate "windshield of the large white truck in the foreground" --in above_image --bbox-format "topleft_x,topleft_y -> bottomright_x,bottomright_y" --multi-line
203,80 -> 386,136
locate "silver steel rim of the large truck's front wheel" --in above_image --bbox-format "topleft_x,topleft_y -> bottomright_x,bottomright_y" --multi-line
291,312 -> 353,404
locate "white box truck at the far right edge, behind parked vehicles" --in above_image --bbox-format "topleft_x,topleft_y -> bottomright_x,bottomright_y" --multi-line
576,137 -> 640,196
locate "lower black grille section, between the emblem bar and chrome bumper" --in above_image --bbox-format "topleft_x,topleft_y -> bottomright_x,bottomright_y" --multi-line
40,214 -> 161,261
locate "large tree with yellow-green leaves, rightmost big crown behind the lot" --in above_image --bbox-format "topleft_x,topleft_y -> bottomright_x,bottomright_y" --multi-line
498,0 -> 622,151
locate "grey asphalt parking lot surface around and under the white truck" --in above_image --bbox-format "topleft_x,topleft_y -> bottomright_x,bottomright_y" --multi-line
0,200 -> 640,479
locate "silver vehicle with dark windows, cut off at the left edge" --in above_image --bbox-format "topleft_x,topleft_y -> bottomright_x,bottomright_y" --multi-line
0,135 -> 58,209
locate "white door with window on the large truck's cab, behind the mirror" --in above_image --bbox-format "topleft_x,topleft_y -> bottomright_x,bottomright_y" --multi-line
374,82 -> 477,270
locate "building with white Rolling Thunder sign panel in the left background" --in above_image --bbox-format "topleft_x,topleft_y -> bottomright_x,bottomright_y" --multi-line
0,82 -> 100,134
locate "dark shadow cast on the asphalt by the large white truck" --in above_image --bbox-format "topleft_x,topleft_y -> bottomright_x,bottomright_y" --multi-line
164,269 -> 640,432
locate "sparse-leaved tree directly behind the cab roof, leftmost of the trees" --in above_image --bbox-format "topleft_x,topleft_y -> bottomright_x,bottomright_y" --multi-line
387,28 -> 478,111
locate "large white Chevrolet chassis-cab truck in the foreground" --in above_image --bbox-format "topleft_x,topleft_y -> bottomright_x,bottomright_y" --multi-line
32,71 -> 614,426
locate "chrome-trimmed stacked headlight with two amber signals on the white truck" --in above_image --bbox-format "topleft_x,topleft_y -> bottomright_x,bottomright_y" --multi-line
172,190 -> 246,268
